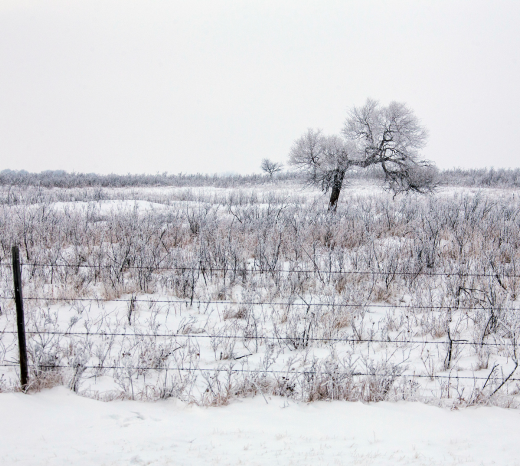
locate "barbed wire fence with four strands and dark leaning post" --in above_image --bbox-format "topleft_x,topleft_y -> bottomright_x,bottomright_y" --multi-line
0,246 -> 520,400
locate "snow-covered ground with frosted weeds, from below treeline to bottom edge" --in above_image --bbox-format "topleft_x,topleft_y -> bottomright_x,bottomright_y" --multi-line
0,184 -> 520,464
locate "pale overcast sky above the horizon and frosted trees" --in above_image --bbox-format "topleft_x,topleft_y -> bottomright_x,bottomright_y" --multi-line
0,0 -> 520,173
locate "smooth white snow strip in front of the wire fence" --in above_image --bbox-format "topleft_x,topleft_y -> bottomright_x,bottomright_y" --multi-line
0,387 -> 520,466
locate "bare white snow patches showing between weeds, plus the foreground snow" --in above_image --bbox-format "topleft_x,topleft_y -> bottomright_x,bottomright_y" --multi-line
0,183 -> 520,466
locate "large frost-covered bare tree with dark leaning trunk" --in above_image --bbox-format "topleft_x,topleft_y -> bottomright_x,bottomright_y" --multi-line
289,99 -> 437,211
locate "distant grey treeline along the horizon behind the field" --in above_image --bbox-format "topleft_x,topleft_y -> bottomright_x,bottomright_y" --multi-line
0,168 -> 520,188
